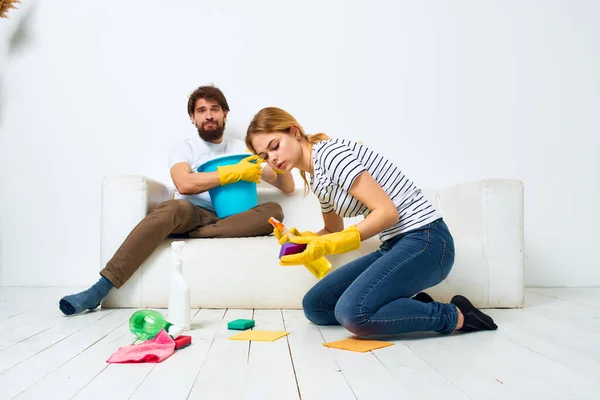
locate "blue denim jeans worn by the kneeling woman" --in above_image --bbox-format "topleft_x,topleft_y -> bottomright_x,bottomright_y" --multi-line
302,219 -> 458,336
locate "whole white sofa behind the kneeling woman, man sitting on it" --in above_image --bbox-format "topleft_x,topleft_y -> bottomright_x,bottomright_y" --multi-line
101,176 -> 523,309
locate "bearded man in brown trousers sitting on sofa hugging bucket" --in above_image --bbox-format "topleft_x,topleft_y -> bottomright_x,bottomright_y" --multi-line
59,86 -> 295,315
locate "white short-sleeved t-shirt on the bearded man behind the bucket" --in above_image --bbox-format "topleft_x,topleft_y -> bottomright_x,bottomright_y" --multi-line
169,136 -> 251,211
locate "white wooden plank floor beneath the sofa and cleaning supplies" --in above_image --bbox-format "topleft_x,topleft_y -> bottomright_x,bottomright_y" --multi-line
0,287 -> 600,400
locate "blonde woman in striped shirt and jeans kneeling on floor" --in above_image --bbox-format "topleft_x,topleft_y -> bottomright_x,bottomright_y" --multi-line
246,107 -> 497,336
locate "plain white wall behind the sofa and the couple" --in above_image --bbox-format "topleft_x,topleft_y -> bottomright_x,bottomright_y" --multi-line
0,0 -> 600,286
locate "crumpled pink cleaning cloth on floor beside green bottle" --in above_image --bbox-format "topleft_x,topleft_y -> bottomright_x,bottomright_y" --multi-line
106,329 -> 175,363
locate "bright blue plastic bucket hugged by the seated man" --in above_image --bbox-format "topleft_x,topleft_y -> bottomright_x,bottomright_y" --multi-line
197,153 -> 258,218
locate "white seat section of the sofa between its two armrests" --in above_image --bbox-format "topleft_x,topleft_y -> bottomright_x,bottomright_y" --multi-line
115,237 -> 488,309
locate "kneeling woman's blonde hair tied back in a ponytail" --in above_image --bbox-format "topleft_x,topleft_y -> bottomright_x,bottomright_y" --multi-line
246,107 -> 329,193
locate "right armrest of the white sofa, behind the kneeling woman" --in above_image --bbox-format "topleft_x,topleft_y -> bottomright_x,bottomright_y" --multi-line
434,179 -> 524,307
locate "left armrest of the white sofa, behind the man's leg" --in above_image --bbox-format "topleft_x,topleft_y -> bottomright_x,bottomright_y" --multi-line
100,175 -> 173,266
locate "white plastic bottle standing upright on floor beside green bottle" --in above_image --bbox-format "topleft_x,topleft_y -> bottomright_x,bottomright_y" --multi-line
167,241 -> 190,330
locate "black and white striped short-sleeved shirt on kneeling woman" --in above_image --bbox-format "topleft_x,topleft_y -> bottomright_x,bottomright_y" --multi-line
310,139 -> 441,242
